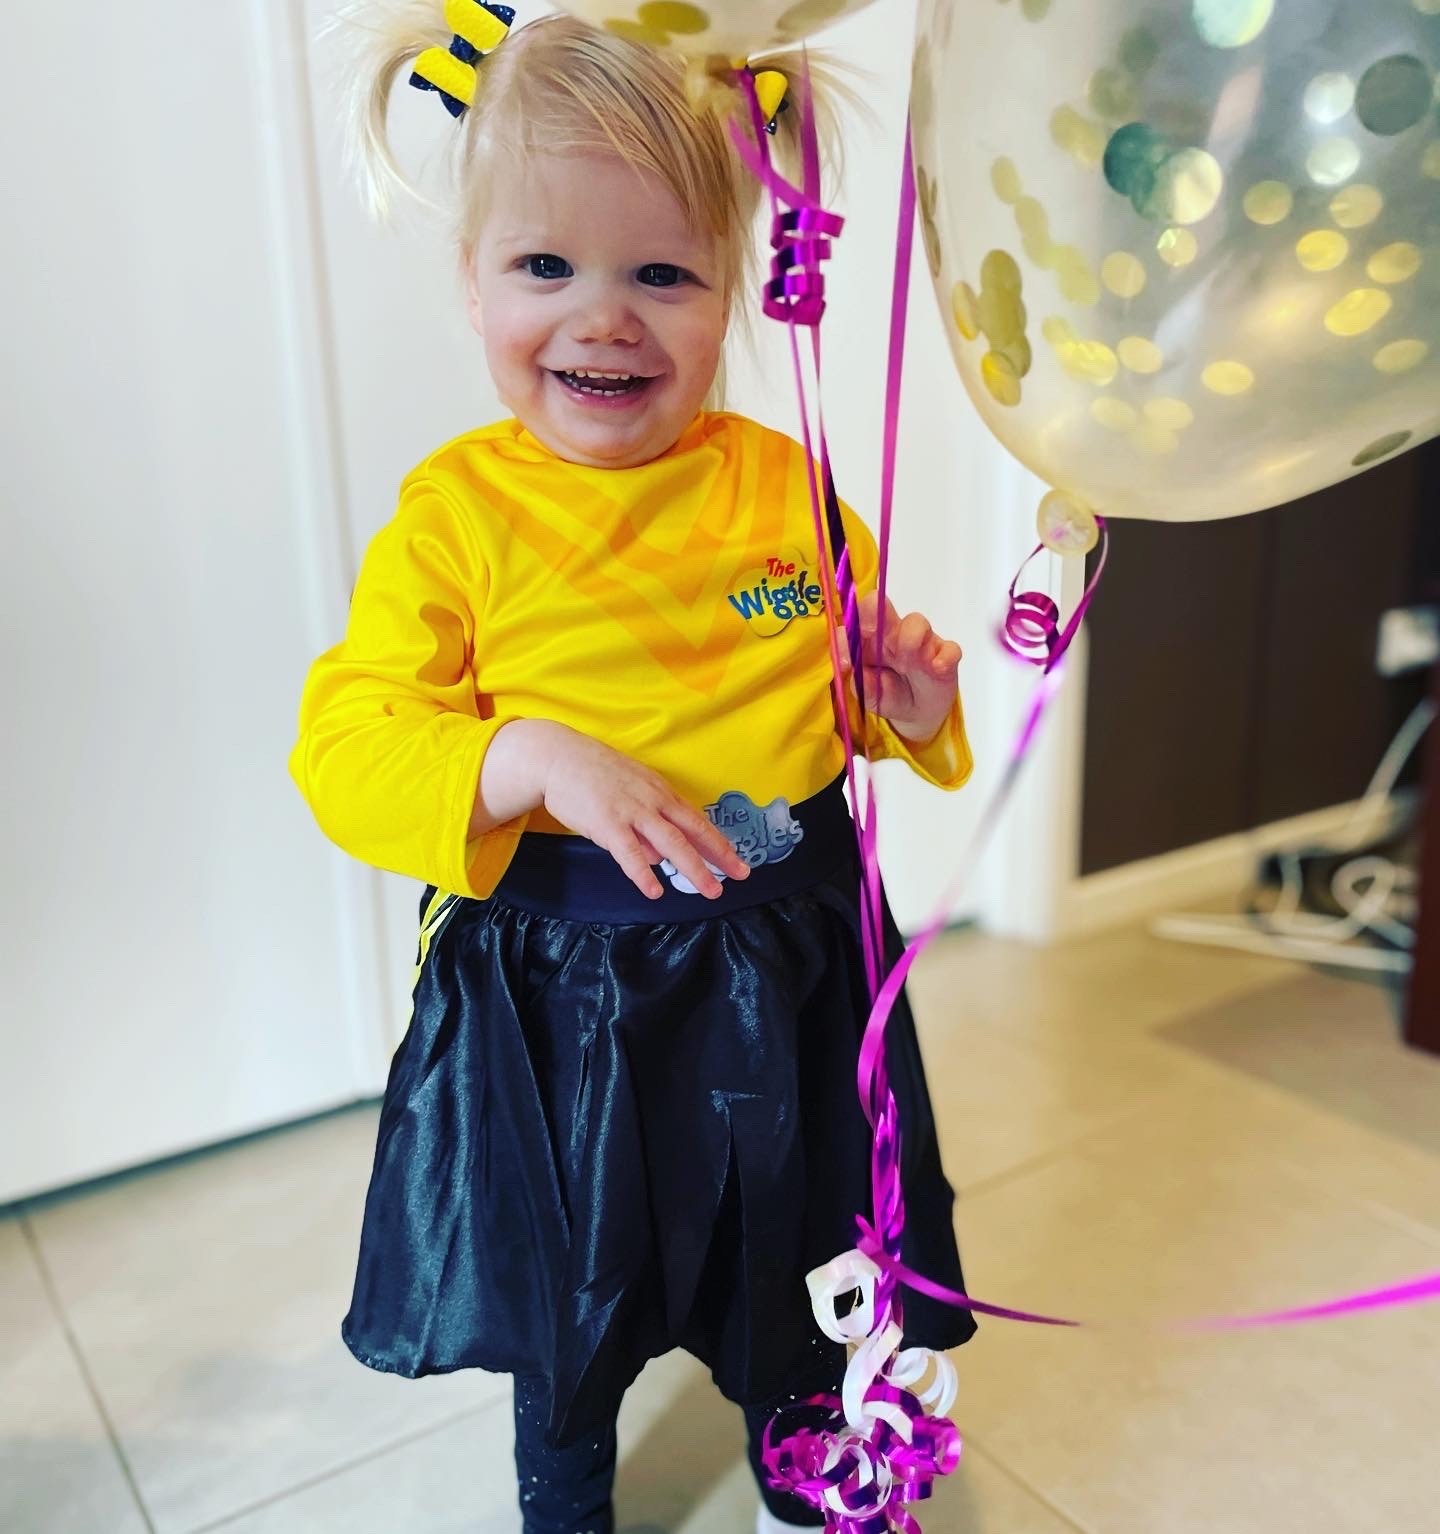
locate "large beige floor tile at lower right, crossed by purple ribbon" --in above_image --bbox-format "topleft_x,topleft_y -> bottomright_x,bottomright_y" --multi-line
957,1085 -> 1440,1534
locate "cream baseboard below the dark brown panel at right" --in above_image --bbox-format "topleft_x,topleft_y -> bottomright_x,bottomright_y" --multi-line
1057,790 -> 1414,937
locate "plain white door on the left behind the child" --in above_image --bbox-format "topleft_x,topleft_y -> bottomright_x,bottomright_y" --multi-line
0,0 -> 395,1201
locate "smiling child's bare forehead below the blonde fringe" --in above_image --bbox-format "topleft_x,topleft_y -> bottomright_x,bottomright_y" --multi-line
486,153 -> 716,253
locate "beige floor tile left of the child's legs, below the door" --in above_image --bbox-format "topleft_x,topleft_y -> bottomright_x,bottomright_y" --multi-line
23,1111 -> 508,1534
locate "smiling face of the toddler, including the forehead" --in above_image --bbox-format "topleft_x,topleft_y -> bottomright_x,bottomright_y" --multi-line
468,155 -> 727,468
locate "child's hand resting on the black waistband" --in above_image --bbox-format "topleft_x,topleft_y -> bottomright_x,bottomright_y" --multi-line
533,726 -> 750,900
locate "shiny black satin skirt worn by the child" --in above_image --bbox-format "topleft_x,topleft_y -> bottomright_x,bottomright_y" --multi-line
342,790 -> 975,1443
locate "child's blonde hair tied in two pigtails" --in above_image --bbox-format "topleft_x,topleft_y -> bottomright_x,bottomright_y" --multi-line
332,0 -> 848,308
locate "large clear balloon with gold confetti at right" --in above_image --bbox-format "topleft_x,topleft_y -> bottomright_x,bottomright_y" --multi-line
914,0 -> 1440,539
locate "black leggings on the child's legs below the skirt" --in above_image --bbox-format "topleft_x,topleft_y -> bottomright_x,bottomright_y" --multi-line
515,1379 -> 825,1534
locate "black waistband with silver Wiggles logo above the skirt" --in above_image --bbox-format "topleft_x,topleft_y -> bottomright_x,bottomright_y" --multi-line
495,778 -> 854,923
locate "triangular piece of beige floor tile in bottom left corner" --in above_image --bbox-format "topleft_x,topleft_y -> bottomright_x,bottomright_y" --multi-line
0,1218 -> 146,1534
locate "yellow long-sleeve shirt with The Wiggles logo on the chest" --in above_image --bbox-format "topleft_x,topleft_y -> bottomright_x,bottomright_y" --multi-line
290,413 -> 971,899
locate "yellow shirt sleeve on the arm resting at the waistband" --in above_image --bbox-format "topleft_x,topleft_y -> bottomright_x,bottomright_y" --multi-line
290,480 -> 529,899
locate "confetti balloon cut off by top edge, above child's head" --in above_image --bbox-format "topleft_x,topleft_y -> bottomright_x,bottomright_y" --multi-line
561,0 -> 871,63
